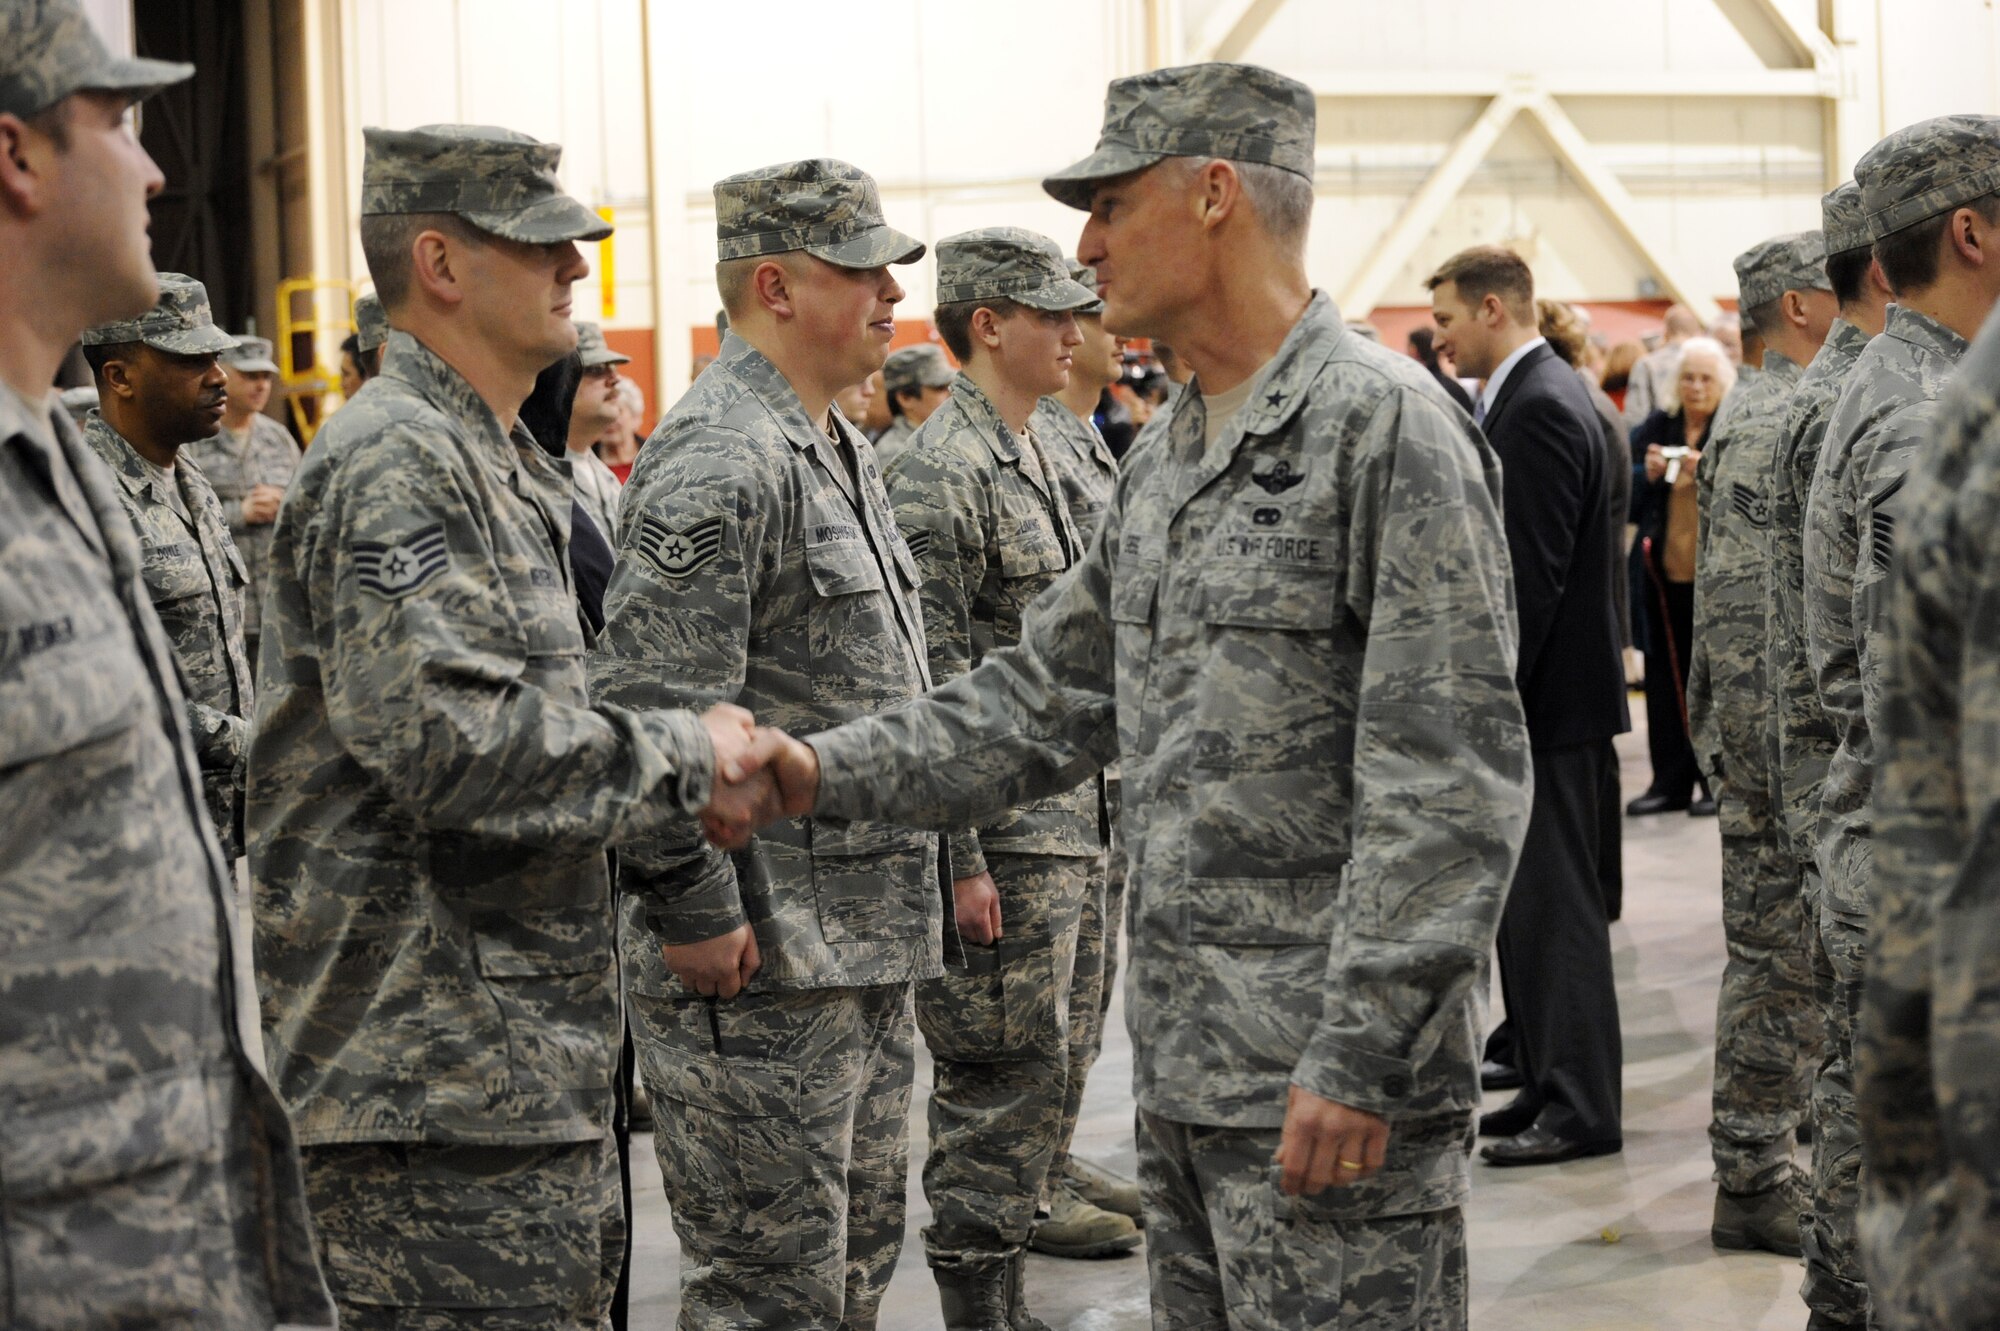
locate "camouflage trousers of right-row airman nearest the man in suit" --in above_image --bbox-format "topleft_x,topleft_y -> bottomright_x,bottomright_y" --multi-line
1708,785 -> 1824,1193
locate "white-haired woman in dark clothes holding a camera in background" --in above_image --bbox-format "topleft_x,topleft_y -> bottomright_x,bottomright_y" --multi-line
1626,338 -> 1736,815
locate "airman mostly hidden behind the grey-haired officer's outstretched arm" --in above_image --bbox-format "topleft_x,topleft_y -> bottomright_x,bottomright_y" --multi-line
1030,260 -> 1142,1231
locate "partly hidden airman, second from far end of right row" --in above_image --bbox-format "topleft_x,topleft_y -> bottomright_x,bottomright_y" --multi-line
1766,180 -> 1882,1329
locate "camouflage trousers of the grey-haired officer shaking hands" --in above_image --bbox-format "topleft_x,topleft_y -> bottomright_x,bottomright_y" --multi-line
1138,1109 -> 1466,1331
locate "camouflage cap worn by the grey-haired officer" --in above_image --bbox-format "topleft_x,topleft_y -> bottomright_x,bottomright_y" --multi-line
1042,64 -> 1318,210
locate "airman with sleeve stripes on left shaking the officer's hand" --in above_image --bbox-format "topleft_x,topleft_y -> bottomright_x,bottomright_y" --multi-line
250,126 -> 736,1329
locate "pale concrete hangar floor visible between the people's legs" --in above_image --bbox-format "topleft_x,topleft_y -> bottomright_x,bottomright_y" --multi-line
632,727 -> 1806,1331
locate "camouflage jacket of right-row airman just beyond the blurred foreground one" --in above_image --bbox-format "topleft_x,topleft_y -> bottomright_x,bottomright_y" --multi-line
1806,306 -> 1966,915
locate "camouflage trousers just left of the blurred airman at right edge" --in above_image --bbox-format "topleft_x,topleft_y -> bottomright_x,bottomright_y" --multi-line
1798,869 -> 1872,1327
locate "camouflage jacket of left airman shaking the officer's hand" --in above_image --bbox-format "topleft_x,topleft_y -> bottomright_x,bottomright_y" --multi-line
250,332 -> 714,1145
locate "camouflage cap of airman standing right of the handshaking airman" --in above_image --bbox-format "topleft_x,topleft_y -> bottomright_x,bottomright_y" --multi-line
716,158 -> 924,268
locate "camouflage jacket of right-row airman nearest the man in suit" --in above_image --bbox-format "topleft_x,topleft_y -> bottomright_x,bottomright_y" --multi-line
1688,352 -> 1804,815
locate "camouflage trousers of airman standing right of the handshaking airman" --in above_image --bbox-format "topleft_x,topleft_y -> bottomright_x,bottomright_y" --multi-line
628,983 -> 916,1331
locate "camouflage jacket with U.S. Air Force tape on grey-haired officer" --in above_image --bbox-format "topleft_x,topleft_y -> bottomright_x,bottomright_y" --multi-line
814,294 -> 1532,1215
